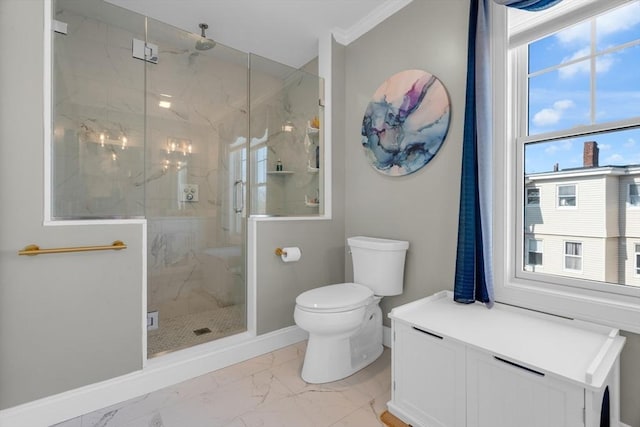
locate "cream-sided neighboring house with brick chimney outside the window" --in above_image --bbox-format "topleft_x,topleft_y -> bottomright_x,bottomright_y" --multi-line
523,141 -> 640,286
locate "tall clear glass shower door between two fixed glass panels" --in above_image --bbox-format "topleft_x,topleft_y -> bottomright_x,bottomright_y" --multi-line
145,19 -> 247,357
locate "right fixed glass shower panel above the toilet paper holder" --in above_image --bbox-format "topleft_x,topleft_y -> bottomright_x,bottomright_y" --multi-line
250,55 -> 322,216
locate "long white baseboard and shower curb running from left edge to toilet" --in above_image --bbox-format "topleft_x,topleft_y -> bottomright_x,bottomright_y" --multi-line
0,326 -> 308,427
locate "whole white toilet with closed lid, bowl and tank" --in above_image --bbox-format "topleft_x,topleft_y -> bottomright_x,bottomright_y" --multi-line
293,236 -> 409,384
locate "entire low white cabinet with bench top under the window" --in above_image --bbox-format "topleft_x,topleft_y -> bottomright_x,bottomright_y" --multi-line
388,292 -> 624,427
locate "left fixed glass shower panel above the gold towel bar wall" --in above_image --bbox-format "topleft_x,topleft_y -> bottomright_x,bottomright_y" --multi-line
52,0 -> 145,218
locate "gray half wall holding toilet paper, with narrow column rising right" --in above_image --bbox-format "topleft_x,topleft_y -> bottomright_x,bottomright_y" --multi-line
256,42 -> 345,334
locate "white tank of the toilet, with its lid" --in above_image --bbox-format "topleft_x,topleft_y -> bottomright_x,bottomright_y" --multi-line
347,236 -> 409,296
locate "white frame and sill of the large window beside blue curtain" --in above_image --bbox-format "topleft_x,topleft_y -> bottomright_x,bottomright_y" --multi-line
489,0 -> 640,333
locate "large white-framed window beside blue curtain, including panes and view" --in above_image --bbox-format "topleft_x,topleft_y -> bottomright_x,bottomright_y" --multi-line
496,0 -> 640,333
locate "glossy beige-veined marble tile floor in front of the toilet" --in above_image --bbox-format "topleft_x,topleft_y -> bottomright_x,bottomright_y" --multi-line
55,341 -> 391,427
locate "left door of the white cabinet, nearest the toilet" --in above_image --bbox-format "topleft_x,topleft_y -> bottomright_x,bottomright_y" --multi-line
393,323 -> 465,427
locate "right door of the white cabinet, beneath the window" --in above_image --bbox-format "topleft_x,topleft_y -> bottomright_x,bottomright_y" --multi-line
467,348 -> 584,427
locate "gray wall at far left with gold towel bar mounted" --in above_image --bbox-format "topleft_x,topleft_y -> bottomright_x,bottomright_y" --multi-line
0,0 -> 143,409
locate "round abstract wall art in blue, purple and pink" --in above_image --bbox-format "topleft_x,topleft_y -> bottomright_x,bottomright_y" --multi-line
362,70 -> 451,176
